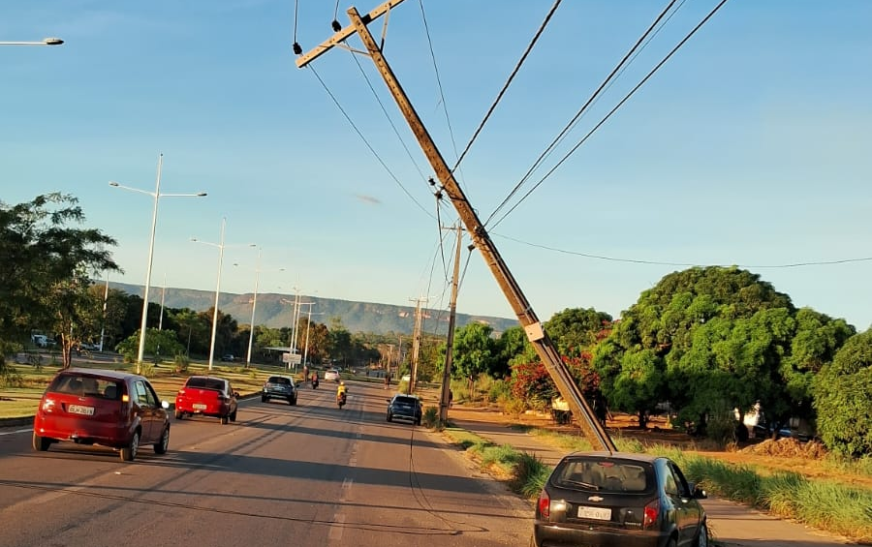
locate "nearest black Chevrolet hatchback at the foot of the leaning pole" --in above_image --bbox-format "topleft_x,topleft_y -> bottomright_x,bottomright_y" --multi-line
533,452 -> 709,547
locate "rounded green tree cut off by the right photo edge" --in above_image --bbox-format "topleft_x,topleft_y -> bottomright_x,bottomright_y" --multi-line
813,329 -> 872,456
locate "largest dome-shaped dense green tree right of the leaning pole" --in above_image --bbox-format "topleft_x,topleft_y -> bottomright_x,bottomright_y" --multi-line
594,267 -> 795,430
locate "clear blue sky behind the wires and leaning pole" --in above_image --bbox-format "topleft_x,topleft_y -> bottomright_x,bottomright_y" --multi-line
0,0 -> 872,329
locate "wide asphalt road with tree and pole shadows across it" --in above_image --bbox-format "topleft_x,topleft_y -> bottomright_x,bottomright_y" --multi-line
0,383 -> 531,547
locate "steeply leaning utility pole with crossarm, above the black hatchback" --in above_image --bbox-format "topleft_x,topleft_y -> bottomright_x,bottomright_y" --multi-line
296,0 -> 617,452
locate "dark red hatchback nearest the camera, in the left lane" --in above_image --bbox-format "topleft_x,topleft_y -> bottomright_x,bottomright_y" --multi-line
33,368 -> 170,462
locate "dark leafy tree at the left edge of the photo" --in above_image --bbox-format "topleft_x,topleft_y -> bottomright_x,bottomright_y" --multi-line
0,193 -> 119,366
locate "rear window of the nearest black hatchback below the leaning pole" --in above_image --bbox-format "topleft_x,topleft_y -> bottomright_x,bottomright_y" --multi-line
552,458 -> 654,493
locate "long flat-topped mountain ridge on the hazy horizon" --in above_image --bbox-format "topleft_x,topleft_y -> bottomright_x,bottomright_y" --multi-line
109,283 -> 518,334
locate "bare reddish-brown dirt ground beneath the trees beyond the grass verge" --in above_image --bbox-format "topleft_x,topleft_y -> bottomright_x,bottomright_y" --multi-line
450,405 -> 872,489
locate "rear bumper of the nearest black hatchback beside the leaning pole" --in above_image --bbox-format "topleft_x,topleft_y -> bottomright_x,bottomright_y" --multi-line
533,522 -> 669,547
